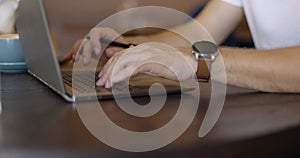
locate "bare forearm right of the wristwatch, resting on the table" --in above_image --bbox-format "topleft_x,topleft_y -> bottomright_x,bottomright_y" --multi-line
220,47 -> 300,92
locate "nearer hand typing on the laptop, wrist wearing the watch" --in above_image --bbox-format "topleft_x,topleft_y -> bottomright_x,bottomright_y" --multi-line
96,43 -> 198,88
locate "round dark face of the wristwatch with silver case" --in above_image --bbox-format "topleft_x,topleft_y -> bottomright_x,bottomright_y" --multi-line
192,41 -> 218,60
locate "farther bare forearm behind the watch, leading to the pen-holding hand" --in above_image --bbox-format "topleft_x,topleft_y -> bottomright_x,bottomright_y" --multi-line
129,0 -> 243,48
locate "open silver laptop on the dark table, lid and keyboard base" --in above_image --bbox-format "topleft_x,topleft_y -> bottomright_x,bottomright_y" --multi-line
16,0 -> 194,102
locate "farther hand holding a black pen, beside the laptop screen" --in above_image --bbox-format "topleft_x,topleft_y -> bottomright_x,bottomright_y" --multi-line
66,27 -> 127,64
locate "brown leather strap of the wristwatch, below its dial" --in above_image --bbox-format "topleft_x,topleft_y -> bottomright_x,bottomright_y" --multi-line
196,59 -> 211,82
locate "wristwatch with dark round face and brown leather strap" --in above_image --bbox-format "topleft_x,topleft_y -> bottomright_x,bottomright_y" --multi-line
192,41 -> 219,82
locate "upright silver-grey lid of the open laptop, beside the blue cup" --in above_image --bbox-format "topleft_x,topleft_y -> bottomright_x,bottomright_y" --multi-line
16,0 -> 65,95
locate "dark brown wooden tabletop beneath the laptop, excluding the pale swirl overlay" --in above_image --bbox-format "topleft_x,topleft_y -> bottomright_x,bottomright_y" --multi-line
0,73 -> 300,158
